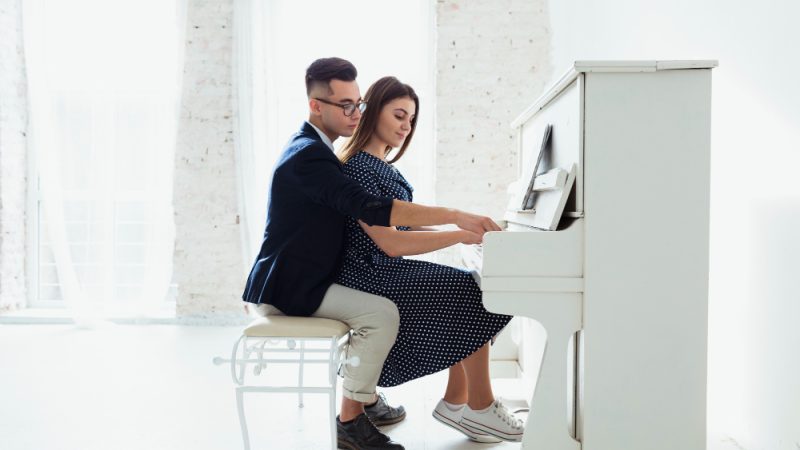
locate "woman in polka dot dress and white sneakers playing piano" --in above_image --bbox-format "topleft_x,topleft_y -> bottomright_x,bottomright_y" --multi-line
336,77 -> 523,442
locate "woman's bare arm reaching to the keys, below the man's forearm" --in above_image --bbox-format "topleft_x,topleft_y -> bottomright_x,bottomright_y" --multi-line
359,221 -> 483,257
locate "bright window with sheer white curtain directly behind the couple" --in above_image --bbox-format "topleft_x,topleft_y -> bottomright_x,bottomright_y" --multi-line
234,0 -> 435,271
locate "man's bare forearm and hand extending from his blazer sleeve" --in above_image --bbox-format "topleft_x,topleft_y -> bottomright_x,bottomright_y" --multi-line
389,200 -> 501,236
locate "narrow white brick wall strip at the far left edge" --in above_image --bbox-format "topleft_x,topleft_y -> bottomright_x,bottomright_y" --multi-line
0,0 -> 28,312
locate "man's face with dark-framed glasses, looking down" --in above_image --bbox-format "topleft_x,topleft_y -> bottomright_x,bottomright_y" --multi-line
309,80 -> 361,137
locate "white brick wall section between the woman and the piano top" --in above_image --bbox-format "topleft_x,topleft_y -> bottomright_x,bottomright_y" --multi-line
436,0 -> 552,264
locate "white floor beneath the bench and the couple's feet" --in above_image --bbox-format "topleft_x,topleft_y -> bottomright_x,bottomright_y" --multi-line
0,324 -> 520,450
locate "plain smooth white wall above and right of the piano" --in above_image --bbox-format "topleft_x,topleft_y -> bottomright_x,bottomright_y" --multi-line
549,0 -> 800,450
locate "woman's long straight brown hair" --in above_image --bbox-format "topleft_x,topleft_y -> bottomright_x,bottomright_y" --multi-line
337,77 -> 419,164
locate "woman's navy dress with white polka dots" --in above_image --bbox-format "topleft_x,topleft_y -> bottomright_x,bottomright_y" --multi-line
336,151 -> 511,387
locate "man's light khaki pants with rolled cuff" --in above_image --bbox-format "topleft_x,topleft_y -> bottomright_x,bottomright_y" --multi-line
255,284 -> 400,403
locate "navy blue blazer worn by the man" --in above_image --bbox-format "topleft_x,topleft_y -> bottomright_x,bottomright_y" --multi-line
242,122 -> 392,316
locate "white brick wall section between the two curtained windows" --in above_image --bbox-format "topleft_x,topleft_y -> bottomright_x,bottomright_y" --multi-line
174,0 -> 244,317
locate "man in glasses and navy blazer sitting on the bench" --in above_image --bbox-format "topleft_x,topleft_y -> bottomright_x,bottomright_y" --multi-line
243,58 -> 500,450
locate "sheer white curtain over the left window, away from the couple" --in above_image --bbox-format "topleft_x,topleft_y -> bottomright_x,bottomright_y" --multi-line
23,0 -> 186,325
